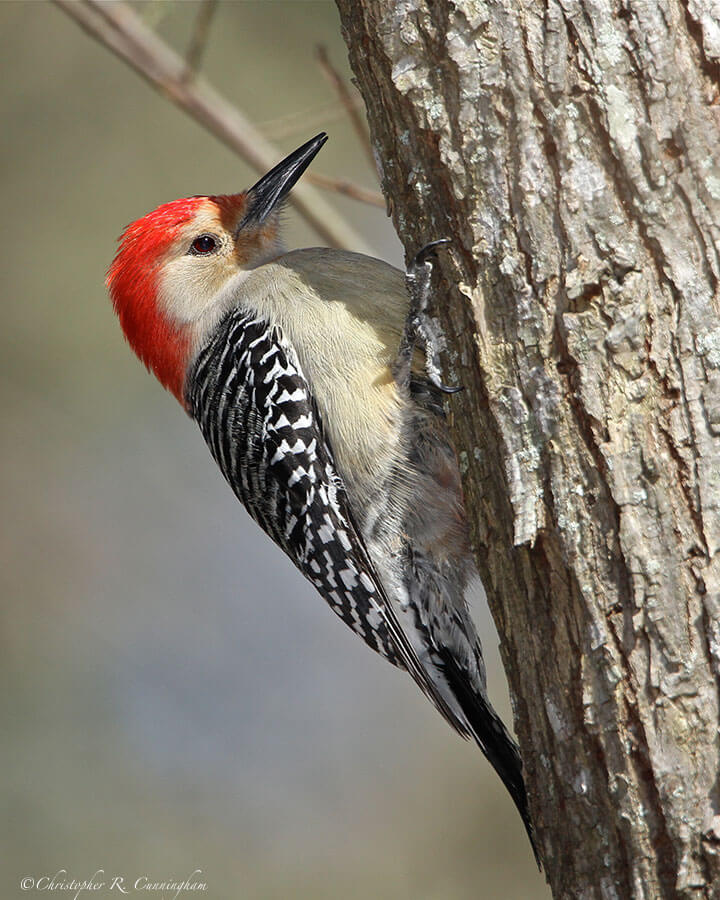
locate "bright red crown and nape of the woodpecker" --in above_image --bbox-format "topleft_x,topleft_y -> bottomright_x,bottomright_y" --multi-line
107,197 -> 207,405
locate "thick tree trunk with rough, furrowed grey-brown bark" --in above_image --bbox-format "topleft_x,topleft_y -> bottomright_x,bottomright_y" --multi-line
338,0 -> 720,900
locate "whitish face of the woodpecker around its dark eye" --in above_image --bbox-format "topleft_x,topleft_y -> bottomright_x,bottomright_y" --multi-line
158,200 -> 280,325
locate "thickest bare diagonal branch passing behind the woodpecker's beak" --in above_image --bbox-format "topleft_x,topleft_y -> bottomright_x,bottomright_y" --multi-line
54,0 -> 380,253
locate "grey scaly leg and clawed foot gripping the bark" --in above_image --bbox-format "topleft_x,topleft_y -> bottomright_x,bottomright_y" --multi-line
393,238 -> 462,394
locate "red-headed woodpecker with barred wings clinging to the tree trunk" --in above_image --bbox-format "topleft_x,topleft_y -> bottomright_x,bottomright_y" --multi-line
107,133 -> 537,858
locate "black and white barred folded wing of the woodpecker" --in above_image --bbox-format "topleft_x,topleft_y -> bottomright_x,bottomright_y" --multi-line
189,311 -> 458,716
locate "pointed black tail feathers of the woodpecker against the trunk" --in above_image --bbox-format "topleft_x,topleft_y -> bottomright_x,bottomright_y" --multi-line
441,651 -> 542,871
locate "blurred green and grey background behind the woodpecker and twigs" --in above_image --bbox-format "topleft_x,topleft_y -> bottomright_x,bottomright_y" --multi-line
0,2 -> 548,900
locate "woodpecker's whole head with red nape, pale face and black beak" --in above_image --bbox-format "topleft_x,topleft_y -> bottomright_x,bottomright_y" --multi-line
107,133 -> 327,404
